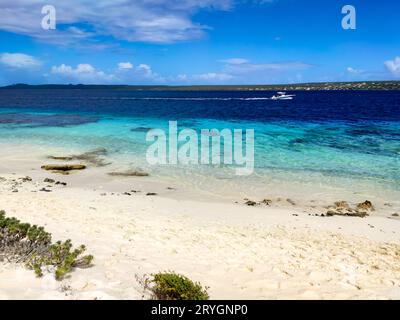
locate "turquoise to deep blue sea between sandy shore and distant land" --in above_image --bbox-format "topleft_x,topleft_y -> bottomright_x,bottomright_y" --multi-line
0,89 -> 400,200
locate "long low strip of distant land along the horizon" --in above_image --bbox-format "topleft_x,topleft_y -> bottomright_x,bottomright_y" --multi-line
0,81 -> 400,91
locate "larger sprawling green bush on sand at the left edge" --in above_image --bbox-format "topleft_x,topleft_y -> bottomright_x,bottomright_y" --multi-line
0,211 -> 93,280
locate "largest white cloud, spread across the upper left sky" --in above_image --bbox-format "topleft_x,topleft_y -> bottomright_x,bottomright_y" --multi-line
0,0 -> 235,45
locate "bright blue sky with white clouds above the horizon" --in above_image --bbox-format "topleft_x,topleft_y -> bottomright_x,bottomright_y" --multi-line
0,0 -> 400,85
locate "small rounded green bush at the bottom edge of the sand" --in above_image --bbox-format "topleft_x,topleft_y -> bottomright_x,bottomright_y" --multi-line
149,272 -> 209,300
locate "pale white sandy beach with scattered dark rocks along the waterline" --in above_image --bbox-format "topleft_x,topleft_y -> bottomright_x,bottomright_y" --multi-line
0,145 -> 400,299
